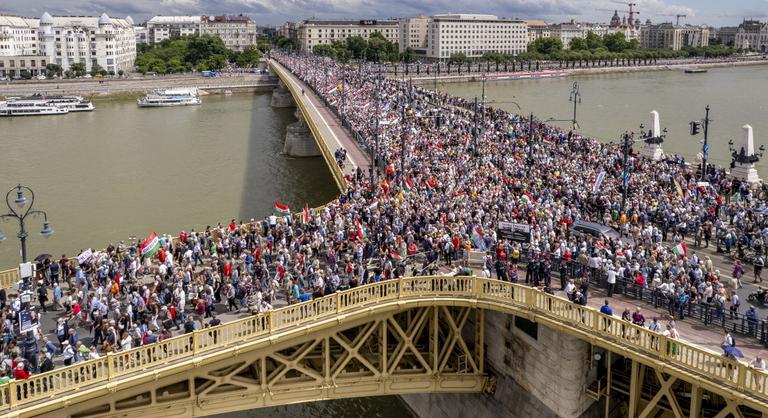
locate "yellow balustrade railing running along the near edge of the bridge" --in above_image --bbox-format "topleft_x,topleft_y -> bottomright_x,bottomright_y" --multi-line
0,276 -> 768,410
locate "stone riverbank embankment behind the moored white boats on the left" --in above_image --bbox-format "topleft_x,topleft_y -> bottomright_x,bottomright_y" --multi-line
0,74 -> 277,97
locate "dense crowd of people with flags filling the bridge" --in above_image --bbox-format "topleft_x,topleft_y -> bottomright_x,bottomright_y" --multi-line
0,50 -> 768,384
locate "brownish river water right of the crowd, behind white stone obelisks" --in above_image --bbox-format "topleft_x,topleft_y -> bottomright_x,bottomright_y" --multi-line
438,65 -> 768,178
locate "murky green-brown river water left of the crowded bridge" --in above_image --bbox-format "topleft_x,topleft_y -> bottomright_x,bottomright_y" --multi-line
0,93 -> 337,270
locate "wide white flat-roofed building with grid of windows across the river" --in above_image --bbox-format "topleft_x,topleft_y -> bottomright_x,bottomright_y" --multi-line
427,14 -> 528,60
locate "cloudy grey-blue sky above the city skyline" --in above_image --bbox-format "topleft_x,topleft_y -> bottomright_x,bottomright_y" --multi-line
0,0 -> 768,26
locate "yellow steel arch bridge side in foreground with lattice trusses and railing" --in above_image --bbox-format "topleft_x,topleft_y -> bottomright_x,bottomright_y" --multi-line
0,277 -> 768,417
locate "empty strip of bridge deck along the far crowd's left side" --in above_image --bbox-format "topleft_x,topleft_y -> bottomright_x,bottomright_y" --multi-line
270,60 -> 371,181
